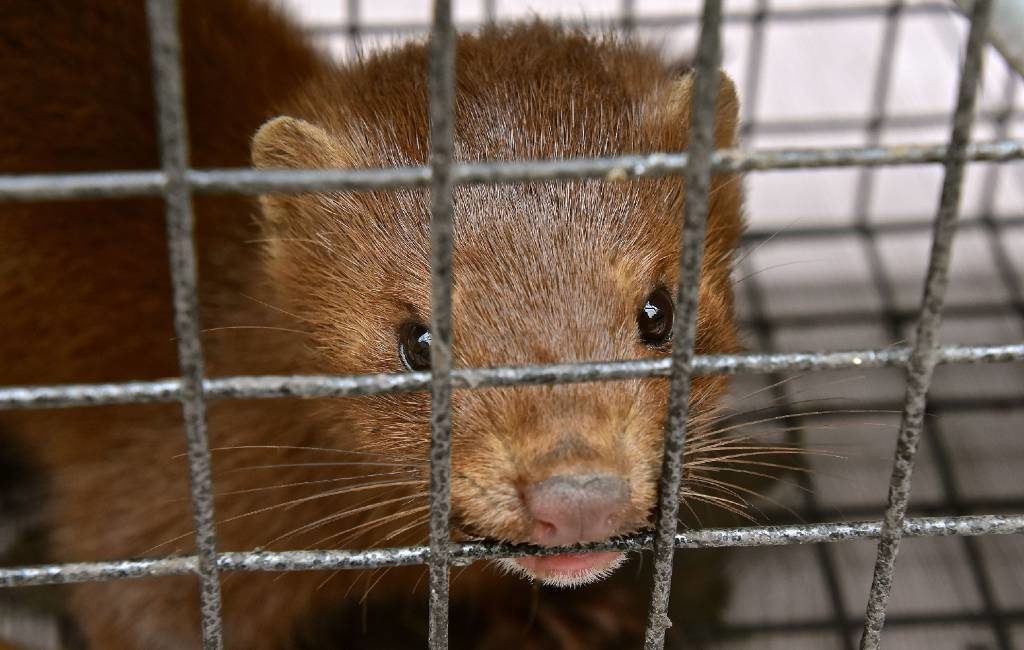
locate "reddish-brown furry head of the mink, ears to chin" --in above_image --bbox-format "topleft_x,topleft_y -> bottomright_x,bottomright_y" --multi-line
253,25 -> 740,584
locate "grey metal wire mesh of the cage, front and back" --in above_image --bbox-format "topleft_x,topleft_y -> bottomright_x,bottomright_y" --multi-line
0,0 -> 1024,648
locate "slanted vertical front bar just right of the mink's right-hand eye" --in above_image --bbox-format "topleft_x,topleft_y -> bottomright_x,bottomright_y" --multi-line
644,0 -> 722,650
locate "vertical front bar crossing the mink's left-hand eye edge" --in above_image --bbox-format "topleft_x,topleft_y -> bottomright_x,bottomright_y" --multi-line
428,0 -> 456,649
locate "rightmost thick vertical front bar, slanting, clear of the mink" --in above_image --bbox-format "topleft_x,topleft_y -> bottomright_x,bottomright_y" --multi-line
860,0 -> 992,650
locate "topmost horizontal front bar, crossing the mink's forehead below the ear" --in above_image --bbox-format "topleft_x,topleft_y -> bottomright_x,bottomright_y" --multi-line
0,139 -> 1024,201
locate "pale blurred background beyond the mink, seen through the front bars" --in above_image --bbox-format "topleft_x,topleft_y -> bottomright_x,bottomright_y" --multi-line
0,0 -> 1024,650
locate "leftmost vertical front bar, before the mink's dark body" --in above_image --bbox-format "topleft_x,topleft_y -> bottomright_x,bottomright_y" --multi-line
145,0 -> 222,650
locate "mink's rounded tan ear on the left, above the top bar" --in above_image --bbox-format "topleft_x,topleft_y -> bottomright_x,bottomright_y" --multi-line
252,116 -> 344,169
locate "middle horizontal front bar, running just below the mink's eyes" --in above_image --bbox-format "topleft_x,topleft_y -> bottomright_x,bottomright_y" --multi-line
0,343 -> 1024,409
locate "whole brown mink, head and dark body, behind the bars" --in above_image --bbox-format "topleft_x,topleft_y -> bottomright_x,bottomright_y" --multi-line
0,0 -> 741,649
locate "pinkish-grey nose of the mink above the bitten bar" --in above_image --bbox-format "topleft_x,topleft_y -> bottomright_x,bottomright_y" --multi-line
524,474 -> 630,547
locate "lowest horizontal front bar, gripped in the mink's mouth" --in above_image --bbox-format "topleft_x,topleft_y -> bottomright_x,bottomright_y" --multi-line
0,514 -> 1024,588
